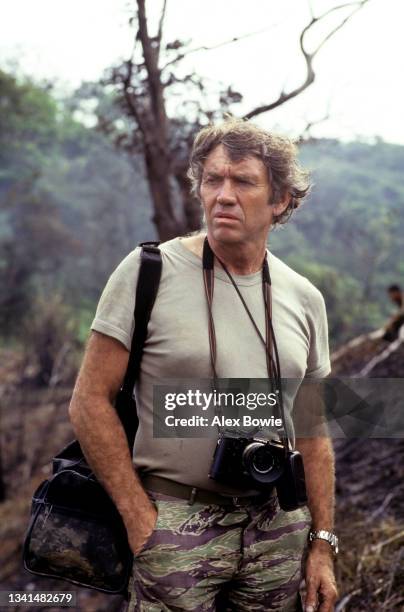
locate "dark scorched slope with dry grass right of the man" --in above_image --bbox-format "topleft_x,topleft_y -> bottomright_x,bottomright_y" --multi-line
332,330 -> 404,612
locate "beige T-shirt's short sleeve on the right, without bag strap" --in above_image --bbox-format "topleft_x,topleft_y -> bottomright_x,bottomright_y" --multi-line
305,283 -> 331,378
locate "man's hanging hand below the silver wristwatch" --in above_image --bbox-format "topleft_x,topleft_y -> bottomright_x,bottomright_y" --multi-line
304,541 -> 338,612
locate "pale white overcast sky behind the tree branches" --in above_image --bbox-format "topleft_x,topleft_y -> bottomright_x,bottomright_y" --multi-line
0,0 -> 404,144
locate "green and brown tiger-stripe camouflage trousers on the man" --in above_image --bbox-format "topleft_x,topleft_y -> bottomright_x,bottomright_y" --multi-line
127,492 -> 310,612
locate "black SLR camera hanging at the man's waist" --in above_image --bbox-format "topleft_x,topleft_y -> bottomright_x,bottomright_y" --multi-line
209,433 -> 307,511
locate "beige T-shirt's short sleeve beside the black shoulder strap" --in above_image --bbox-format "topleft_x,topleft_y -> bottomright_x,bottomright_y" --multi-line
91,248 -> 140,351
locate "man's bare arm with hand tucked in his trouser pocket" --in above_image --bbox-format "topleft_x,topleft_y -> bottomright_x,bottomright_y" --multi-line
69,332 -> 156,553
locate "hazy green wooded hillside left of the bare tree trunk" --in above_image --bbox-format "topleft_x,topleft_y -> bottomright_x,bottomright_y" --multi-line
0,72 -> 155,337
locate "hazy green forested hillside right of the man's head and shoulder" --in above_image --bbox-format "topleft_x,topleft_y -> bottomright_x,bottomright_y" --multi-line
271,140 -> 404,345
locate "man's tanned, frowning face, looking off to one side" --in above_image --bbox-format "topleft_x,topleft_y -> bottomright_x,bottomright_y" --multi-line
200,145 -> 287,243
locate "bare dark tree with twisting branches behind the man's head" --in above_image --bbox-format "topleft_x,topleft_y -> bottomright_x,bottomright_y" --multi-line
103,0 -> 369,240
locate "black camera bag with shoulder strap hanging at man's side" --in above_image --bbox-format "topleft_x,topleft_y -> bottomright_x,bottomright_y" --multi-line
23,242 -> 161,594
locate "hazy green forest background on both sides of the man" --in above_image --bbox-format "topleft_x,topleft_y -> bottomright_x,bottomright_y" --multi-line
0,67 -> 404,346
